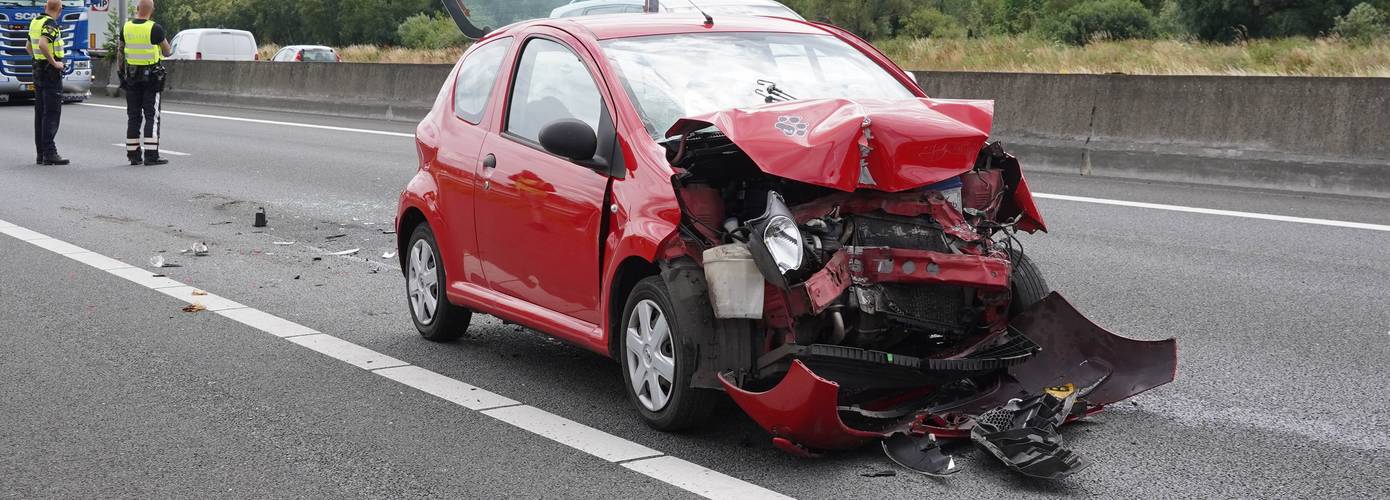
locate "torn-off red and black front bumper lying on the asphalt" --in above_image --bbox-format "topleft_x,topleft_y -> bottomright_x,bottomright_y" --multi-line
720,293 -> 1177,478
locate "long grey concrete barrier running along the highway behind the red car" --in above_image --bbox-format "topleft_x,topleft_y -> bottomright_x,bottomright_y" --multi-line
97,61 -> 1390,199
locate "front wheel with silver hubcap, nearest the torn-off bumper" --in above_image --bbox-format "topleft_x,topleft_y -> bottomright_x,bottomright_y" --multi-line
619,276 -> 719,431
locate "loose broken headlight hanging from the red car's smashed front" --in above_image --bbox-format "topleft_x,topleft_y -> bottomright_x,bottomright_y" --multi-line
748,192 -> 805,288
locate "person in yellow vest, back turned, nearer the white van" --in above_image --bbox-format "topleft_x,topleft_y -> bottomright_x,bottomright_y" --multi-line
120,0 -> 174,165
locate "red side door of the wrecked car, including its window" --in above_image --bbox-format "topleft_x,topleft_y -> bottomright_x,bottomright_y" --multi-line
477,32 -> 612,324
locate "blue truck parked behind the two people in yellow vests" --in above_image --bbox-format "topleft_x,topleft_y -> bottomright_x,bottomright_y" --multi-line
0,0 -> 95,103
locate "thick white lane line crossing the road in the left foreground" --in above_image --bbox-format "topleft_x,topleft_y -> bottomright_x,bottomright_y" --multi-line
0,215 -> 790,500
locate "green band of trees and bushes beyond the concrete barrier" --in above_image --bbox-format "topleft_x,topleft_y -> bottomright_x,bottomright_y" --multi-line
149,0 -> 1390,49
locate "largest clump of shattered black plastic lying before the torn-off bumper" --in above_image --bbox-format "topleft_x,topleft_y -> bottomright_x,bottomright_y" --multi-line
970,386 -> 1091,479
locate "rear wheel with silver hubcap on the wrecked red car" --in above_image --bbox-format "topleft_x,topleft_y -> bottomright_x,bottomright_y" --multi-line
406,222 -> 473,342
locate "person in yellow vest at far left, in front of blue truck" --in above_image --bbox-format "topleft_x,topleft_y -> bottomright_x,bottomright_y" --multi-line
28,0 -> 68,165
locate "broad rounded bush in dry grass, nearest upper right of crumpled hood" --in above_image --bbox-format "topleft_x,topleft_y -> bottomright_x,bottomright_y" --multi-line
1045,0 -> 1154,44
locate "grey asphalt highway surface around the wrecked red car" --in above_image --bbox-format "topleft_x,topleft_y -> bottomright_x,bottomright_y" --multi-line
0,99 -> 1390,499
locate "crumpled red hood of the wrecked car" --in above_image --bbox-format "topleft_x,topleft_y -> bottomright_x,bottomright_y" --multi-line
667,99 -> 994,192
